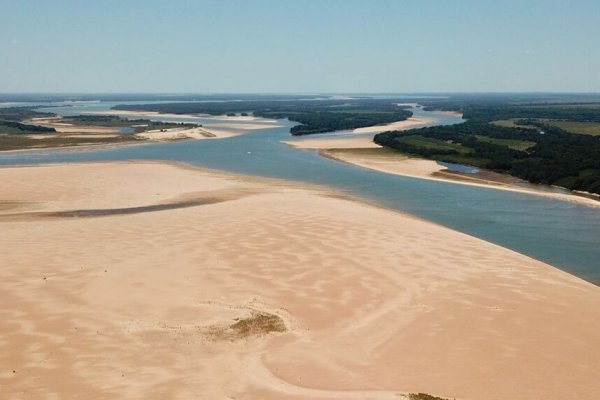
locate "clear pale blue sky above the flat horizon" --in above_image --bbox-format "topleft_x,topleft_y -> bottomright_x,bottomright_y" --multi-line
0,0 -> 600,93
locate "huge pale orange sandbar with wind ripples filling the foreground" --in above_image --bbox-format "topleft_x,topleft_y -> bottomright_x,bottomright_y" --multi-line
0,163 -> 600,400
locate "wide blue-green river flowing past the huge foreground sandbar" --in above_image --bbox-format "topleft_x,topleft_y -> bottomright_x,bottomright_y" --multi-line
0,103 -> 600,285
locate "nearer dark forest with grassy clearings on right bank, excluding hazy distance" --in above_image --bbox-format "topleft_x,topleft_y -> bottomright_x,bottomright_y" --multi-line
374,120 -> 600,194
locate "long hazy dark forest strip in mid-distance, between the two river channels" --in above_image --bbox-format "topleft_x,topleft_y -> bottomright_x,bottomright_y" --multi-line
114,99 -> 412,135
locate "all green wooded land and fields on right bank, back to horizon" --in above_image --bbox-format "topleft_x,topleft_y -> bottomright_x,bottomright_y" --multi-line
375,94 -> 600,194
